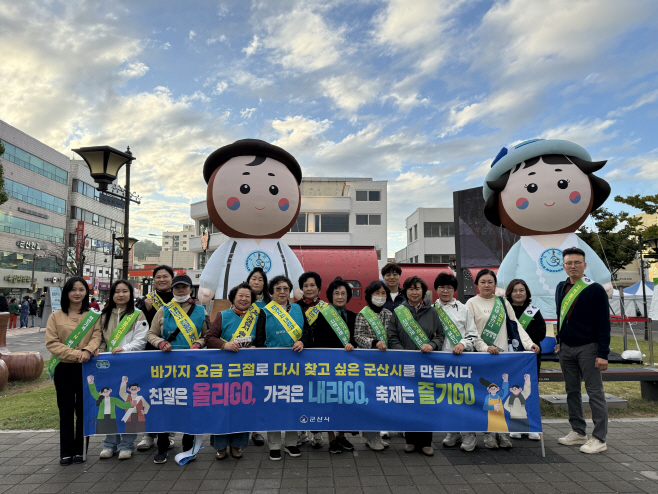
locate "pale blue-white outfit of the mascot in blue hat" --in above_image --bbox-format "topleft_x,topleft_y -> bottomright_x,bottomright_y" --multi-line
497,233 -> 610,319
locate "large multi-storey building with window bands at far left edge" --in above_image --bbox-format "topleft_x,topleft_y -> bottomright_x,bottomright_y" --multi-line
0,120 -> 70,298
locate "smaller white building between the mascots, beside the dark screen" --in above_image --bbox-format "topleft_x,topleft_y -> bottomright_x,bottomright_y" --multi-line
395,208 -> 455,264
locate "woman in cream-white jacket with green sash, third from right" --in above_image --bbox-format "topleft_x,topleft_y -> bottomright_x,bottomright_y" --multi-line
466,269 -> 541,449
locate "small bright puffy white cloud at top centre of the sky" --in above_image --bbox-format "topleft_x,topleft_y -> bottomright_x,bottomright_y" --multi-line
263,8 -> 345,72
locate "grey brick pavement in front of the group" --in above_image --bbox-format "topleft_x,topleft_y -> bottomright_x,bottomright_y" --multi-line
0,420 -> 658,494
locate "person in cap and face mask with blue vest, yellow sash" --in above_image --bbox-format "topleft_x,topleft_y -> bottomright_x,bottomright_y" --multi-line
147,274 -> 208,463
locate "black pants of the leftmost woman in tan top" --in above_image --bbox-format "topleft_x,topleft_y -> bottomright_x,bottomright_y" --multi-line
54,362 -> 84,458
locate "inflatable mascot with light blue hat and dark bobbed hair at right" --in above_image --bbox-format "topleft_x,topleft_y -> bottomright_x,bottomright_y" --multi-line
483,139 -> 612,319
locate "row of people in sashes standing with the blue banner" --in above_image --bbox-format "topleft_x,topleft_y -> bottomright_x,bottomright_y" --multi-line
46,248 -> 610,465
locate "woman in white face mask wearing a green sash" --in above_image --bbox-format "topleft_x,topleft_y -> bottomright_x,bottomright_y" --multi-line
354,280 -> 393,451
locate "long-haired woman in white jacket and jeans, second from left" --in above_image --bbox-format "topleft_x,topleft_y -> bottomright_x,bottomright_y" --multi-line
94,280 -> 149,460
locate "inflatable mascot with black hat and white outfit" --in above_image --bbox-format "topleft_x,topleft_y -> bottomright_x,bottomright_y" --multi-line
199,139 -> 304,306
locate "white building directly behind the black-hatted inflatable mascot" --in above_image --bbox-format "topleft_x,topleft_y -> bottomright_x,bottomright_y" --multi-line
187,177 -> 387,279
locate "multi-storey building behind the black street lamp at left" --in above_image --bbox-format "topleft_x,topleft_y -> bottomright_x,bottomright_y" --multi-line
67,160 -> 124,298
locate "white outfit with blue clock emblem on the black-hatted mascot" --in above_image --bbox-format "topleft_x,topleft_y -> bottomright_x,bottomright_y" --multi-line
199,238 -> 304,299
